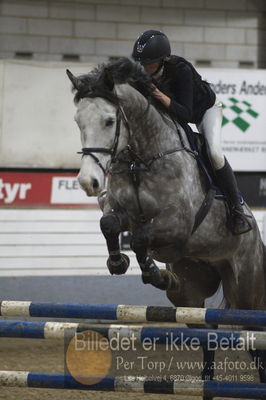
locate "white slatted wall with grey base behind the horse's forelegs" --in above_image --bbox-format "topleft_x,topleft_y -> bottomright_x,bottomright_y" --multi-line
0,209 -> 266,306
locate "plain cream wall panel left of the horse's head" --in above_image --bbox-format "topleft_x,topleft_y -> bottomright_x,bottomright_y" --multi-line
0,60 -> 90,168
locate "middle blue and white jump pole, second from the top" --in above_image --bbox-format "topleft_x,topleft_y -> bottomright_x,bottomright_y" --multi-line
0,320 -> 266,351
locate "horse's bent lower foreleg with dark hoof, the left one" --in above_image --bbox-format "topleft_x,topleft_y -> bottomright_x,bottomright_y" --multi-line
100,213 -> 130,275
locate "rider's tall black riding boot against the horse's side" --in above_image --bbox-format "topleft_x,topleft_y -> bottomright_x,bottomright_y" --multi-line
215,158 -> 252,235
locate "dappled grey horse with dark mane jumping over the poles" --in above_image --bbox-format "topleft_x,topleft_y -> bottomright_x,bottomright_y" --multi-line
68,60 -> 265,396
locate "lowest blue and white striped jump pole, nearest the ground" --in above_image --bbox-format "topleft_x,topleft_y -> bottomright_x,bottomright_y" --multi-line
0,371 -> 266,399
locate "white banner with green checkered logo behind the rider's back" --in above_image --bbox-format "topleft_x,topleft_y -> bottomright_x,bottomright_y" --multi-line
200,69 -> 266,171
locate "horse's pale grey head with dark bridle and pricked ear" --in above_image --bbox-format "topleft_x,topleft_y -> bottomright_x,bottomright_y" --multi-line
67,70 -> 129,196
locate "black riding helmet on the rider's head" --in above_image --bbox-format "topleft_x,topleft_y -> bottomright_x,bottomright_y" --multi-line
132,30 -> 171,65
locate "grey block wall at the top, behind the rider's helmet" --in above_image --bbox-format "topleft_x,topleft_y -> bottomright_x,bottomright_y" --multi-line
0,0 -> 266,68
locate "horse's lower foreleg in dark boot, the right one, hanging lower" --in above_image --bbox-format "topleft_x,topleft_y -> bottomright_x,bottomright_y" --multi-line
131,226 -> 177,290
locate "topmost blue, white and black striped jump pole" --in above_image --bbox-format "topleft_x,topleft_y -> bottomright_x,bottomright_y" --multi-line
0,301 -> 266,327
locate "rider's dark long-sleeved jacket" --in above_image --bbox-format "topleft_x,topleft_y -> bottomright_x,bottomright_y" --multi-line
155,56 -> 216,123
